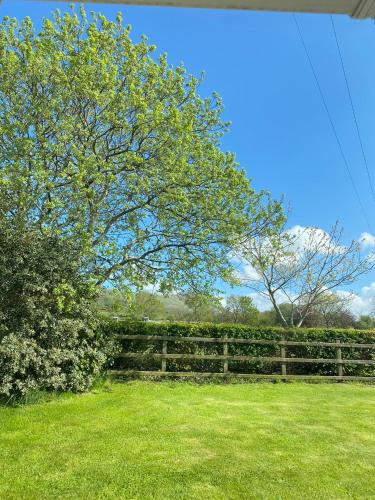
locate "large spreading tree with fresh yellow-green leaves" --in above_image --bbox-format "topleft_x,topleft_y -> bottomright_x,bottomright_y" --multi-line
0,10 -> 279,291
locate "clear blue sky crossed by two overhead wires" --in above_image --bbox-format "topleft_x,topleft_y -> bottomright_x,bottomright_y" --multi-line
0,0 -> 375,312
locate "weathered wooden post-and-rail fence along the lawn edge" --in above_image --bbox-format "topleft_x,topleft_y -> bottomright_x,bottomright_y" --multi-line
112,335 -> 375,382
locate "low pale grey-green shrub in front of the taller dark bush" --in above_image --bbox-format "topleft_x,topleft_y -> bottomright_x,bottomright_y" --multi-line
0,320 -> 113,396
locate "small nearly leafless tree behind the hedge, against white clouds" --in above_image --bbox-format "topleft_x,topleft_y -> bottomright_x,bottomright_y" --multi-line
236,223 -> 375,327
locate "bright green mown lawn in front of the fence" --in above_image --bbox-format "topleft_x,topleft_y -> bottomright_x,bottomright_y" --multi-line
0,382 -> 375,500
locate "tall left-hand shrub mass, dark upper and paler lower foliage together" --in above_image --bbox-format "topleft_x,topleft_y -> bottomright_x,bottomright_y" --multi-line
0,221 -> 113,397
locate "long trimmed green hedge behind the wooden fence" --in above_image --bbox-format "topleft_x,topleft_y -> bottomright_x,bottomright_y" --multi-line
105,322 -> 375,376
